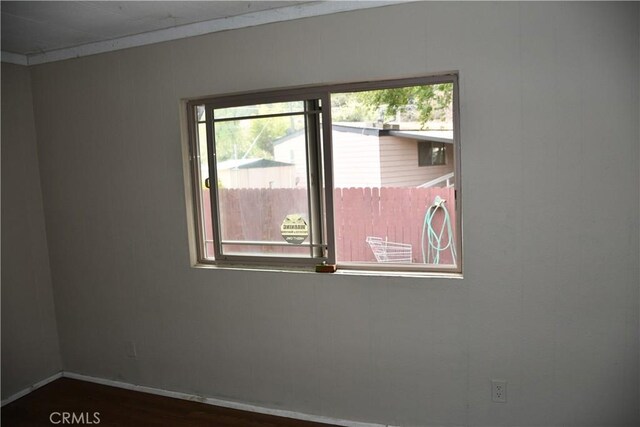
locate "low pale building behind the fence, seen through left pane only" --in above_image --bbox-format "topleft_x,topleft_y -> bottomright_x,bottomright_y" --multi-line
217,159 -> 296,188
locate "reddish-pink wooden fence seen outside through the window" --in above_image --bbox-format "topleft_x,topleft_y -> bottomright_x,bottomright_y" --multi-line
203,187 -> 456,264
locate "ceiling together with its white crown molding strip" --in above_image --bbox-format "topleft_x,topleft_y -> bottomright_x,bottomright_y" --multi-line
0,1 -> 404,65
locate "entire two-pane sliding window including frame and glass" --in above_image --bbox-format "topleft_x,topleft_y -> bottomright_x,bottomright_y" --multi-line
187,75 -> 461,272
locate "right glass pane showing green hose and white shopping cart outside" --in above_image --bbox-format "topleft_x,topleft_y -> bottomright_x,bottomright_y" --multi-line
331,84 -> 458,267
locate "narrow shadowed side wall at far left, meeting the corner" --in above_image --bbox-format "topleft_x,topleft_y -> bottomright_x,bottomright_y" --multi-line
2,63 -> 62,399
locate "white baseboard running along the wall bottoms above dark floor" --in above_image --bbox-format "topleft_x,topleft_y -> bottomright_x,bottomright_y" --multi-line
7,371 -> 387,427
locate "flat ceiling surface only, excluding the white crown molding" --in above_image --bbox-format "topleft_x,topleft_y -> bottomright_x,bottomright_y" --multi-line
0,1 -> 303,55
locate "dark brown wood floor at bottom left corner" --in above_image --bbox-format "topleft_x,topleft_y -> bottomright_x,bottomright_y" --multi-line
2,378 -> 338,427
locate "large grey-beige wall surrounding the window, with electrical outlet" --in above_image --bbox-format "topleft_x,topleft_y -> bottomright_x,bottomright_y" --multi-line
21,2 -> 640,426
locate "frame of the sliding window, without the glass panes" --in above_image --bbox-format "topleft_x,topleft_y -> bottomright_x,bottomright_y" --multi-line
183,72 -> 463,275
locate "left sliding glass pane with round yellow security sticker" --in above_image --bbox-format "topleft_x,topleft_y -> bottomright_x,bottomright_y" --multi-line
214,106 -> 317,258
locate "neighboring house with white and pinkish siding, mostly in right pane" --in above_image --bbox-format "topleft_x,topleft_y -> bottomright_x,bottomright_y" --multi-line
274,124 -> 454,188
